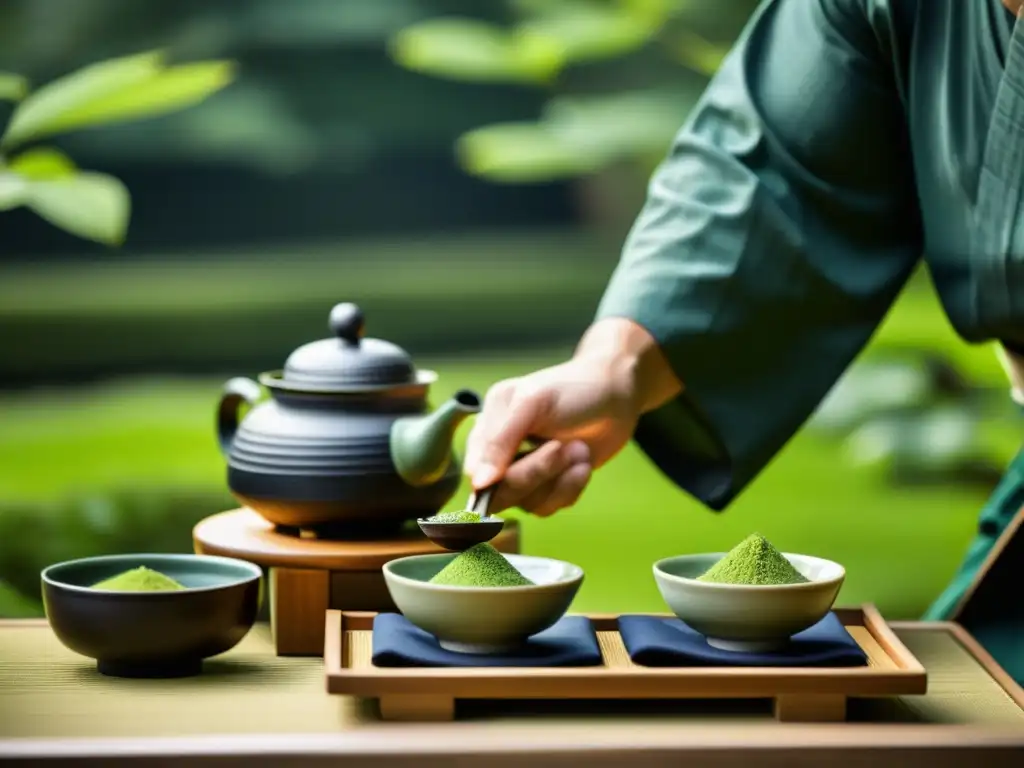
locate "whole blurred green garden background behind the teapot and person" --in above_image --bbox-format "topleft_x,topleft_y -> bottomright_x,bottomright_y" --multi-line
0,0 -> 1021,618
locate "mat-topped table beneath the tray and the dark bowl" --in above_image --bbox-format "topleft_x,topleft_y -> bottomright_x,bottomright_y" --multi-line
0,621 -> 1024,768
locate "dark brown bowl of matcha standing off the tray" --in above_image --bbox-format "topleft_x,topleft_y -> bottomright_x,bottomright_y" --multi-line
41,554 -> 262,678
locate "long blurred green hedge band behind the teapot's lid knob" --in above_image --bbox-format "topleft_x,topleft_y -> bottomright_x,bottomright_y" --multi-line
0,231 -> 616,385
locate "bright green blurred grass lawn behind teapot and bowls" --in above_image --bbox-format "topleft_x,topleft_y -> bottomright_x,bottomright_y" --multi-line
0,256 -> 1018,617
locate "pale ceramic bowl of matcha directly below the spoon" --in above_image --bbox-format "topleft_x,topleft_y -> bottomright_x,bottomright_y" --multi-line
384,552 -> 583,653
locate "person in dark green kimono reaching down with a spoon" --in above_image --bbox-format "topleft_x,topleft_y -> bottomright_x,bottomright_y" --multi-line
465,0 -> 1024,679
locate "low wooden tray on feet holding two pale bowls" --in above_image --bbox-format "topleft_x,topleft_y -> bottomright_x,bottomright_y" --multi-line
324,605 -> 928,722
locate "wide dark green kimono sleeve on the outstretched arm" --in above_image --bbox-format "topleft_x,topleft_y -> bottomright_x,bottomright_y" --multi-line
598,0 -> 922,510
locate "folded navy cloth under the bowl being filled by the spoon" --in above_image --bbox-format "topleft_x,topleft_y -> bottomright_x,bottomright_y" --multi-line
373,613 -> 602,667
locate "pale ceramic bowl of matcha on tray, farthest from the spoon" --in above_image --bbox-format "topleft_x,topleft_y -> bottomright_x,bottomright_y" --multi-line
654,552 -> 846,652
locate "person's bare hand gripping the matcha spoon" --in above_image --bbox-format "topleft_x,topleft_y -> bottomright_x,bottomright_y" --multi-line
465,319 -> 679,516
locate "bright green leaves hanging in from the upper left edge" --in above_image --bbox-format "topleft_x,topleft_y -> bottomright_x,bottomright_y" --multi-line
0,51 -> 233,245
